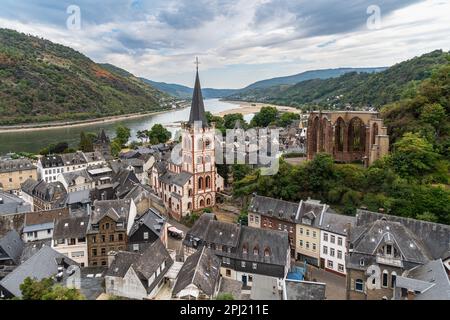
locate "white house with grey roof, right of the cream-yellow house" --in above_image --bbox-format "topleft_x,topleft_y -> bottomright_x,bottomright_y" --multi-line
319,210 -> 356,275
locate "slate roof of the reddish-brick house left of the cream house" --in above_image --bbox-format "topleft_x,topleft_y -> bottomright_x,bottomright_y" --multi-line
248,195 -> 299,222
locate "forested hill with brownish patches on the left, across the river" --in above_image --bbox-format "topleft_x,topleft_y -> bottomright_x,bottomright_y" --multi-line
0,29 -> 171,125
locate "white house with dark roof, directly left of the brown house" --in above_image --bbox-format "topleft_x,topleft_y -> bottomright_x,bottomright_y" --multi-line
52,216 -> 89,267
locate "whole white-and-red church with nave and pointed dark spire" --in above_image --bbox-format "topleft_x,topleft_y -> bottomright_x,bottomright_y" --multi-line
150,65 -> 224,220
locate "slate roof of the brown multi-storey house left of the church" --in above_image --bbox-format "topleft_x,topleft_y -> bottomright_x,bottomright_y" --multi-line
91,199 -> 131,224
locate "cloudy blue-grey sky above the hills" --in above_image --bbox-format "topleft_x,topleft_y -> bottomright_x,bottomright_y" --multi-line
0,0 -> 450,88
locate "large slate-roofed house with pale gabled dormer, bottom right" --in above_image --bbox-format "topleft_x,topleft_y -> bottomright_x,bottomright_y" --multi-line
346,210 -> 450,300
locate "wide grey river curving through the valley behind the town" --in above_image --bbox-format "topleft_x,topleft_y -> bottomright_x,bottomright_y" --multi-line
0,99 -> 253,155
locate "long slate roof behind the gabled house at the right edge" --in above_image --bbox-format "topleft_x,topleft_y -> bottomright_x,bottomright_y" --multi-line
356,210 -> 450,259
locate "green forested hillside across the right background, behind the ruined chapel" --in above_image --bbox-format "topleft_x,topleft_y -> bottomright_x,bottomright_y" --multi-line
228,50 -> 448,109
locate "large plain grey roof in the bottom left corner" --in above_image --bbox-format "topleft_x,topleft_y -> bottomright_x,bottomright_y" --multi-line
0,246 -> 77,297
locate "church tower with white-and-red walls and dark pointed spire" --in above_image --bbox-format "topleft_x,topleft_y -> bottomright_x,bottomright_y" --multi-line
181,60 -> 223,211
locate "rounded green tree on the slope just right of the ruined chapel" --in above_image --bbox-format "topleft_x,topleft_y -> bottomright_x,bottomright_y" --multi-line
390,132 -> 439,180
